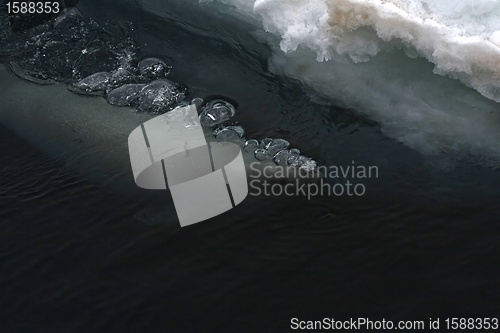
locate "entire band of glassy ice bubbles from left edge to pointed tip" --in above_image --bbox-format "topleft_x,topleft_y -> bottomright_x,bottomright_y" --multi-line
0,2 -> 317,167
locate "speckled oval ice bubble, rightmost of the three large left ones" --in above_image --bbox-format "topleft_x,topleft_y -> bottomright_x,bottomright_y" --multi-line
135,79 -> 185,114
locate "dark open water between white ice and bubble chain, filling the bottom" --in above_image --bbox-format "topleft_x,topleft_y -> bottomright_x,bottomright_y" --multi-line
0,1 -> 500,332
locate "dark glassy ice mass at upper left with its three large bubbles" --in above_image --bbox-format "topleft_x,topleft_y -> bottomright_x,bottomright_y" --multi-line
0,4 -> 186,114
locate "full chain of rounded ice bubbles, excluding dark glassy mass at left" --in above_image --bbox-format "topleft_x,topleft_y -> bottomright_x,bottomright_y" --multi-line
68,58 -> 318,172
